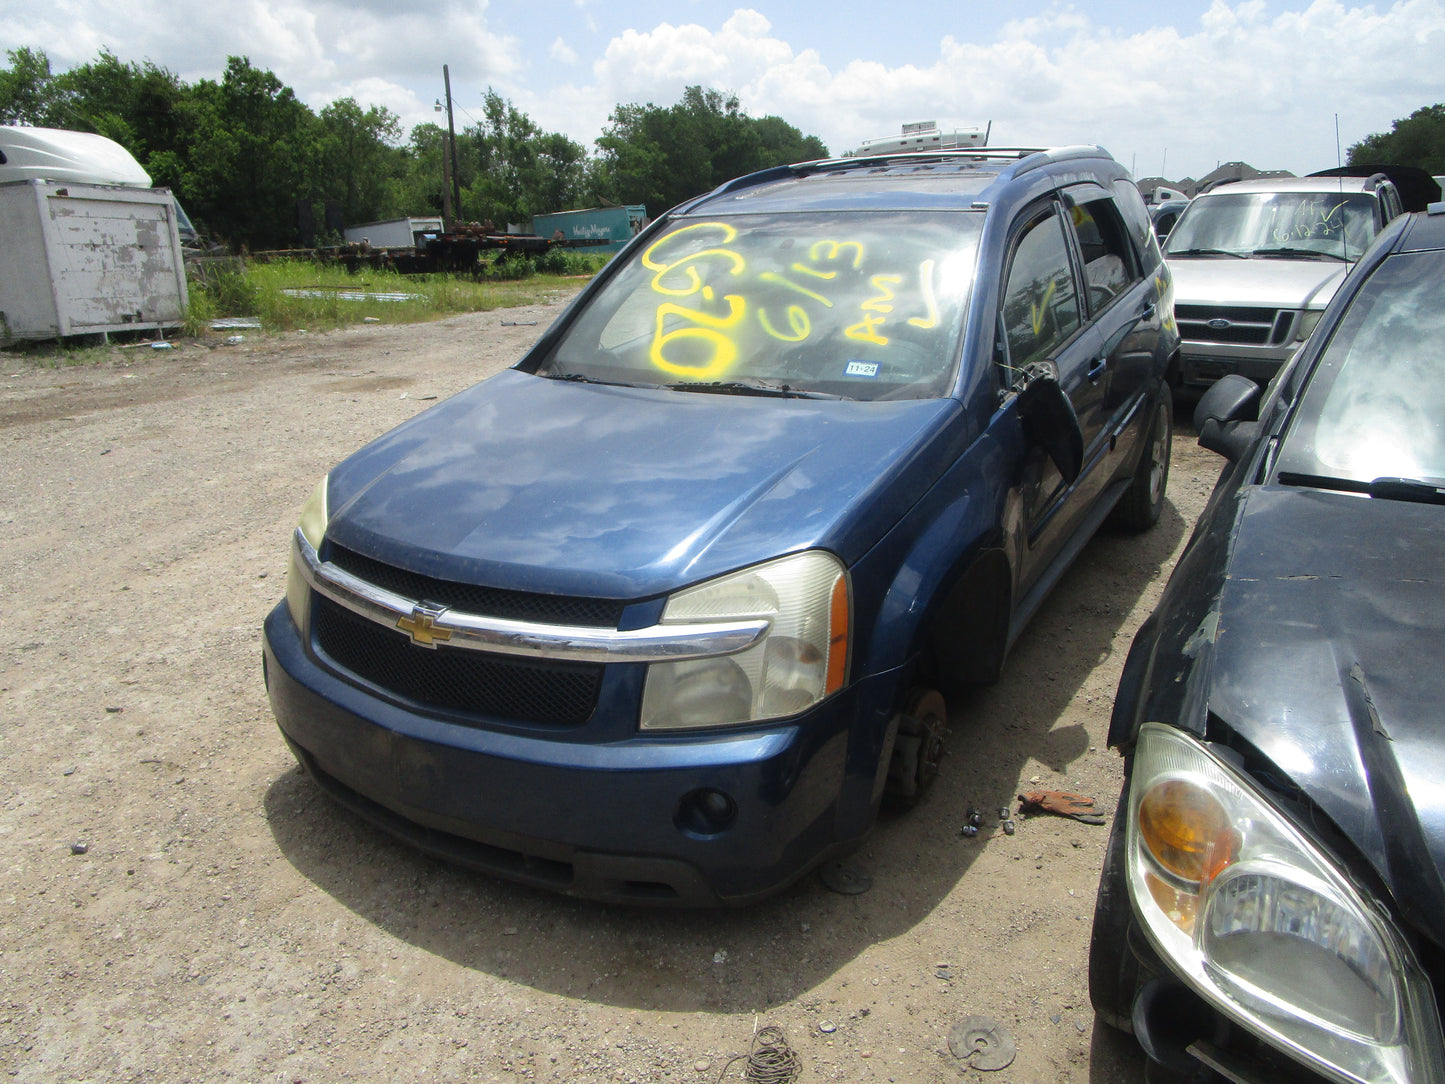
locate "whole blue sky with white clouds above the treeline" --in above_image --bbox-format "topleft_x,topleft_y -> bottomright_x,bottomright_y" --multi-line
0,0 -> 1445,179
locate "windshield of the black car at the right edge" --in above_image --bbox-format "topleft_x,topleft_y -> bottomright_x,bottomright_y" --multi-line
1277,251 -> 1445,491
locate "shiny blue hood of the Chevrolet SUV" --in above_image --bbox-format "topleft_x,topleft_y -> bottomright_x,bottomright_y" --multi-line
327,370 -> 959,598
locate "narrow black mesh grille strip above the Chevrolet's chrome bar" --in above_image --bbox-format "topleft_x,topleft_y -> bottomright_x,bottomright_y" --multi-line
327,543 -> 626,629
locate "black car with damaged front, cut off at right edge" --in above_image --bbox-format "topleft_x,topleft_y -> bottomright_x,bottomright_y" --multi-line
1090,204 -> 1445,1084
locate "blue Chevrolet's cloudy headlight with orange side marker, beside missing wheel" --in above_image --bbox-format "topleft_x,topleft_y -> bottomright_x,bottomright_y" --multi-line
642,549 -> 851,730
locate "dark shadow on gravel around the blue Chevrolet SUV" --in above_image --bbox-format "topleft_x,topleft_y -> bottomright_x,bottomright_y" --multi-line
266,439 -> 1189,1063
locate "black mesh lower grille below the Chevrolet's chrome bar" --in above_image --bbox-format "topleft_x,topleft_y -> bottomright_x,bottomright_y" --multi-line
311,594 -> 603,726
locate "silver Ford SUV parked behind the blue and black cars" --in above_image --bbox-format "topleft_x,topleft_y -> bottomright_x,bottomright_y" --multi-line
1165,173 -> 1403,389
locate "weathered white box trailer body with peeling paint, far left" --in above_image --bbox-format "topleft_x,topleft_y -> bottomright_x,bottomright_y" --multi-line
0,181 -> 188,338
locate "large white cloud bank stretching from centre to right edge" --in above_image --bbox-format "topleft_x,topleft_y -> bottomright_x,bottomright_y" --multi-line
525,0 -> 1445,176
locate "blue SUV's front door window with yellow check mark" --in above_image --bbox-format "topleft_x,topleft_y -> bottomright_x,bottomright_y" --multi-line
1003,211 -> 1081,369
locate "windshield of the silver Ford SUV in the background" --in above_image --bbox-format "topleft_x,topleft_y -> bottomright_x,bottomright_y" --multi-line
1165,192 -> 1380,263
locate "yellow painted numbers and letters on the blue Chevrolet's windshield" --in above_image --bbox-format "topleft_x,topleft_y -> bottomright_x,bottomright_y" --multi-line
642,223 -> 939,380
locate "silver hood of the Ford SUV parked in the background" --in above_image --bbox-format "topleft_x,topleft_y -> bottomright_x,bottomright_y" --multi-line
1169,256 -> 1350,309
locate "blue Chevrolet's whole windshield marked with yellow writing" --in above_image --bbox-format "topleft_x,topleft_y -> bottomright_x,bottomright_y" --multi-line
536,211 -> 984,399
